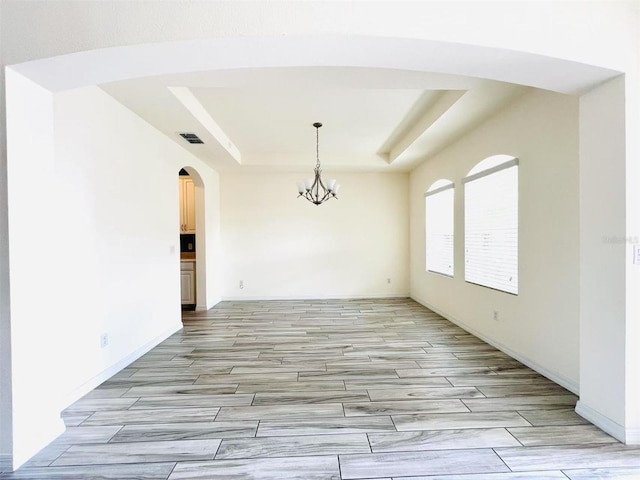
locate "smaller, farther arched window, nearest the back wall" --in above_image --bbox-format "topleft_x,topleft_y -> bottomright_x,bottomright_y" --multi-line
425,180 -> 454,277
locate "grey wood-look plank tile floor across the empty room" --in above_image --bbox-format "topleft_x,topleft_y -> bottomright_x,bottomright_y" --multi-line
5,299 -> 640,480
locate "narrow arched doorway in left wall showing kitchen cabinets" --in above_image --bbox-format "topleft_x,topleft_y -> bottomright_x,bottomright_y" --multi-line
178,166 -> 207,310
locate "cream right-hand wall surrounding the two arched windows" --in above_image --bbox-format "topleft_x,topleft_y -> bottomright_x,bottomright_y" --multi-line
411,90 -> 579,390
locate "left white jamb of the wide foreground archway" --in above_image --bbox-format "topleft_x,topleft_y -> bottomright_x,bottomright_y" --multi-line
6,71 -> 63,466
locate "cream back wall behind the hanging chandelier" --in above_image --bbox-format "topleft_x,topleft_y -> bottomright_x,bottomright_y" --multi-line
221,172 -> 409,299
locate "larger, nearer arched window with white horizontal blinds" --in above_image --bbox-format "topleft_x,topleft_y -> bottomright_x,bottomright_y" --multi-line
463,155 -> 518,295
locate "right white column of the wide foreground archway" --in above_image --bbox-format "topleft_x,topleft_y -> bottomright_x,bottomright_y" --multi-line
576,76 -> 640,444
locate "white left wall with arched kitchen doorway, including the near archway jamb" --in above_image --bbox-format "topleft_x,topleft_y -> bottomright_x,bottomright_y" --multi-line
8,78 -> 220,467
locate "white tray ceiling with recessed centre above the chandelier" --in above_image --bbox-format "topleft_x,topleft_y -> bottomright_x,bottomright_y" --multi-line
101,67 -> 528,171
